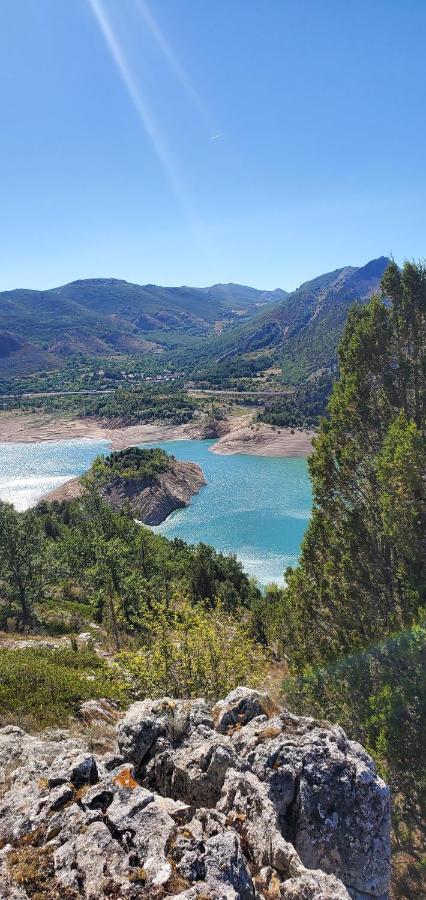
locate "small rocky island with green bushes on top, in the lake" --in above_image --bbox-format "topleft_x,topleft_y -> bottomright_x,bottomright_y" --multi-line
44,447 -> 206,525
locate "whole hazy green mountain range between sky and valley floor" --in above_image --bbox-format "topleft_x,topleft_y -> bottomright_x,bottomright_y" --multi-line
0,257 -> 388,383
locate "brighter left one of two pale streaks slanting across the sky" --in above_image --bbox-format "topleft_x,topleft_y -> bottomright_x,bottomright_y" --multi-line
88,0 -> 198,219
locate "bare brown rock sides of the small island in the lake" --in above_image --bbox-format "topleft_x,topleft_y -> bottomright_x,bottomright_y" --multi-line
43,457 -> 206,525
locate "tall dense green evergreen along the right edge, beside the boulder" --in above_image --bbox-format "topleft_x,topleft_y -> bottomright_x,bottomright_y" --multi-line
253,263 -> 426,872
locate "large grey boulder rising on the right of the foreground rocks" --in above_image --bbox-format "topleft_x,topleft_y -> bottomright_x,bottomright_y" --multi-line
119,688 -> 390,900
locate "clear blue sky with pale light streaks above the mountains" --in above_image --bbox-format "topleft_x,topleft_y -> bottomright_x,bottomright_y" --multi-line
0,0 -> 426,289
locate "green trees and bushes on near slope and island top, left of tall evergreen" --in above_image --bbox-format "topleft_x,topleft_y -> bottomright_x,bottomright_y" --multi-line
0,482 -> 264,727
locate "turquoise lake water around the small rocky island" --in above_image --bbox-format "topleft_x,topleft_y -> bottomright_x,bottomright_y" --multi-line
0,440 -> 311,584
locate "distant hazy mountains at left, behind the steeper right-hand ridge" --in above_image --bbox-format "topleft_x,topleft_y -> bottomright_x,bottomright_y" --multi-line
0,278 -> 285,368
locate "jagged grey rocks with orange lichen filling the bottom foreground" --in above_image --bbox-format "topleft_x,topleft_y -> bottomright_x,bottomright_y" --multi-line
0,688 -> 390,900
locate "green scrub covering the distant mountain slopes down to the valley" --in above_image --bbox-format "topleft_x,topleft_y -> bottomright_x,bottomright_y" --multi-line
0,257 -> 387,393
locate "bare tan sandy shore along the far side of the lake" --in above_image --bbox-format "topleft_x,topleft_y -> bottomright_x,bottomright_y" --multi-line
0,412 -> 313,456
